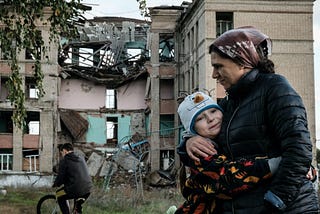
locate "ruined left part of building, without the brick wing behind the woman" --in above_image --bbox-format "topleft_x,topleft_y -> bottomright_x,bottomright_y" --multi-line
0,4 -> 177,184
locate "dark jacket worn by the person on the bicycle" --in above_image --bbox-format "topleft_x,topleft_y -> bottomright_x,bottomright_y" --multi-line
53,152 -> 93,197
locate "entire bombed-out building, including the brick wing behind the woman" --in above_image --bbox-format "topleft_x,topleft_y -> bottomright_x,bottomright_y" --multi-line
0,0 -> 315,187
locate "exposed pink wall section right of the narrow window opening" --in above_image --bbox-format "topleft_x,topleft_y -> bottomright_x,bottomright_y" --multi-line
117,79 -> 147,110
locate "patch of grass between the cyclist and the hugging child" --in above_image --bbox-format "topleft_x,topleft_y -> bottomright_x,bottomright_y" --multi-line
84,185 -> 183,214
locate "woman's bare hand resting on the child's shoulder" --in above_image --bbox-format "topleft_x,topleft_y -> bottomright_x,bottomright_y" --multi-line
186,135 -> 217,161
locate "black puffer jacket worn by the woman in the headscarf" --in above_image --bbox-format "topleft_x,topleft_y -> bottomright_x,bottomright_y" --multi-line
178,70 -> 318,214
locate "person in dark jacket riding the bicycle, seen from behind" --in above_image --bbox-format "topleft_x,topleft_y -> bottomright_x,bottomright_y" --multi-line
52,143 -> 93,214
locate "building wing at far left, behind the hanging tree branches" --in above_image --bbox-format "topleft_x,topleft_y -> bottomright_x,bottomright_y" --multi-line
0,8 -> 59,173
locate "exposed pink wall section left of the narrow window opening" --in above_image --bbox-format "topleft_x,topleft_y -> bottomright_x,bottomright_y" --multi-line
59,79 -> 106,109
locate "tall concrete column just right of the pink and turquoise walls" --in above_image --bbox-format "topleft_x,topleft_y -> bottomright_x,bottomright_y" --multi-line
150,33 -> 160,171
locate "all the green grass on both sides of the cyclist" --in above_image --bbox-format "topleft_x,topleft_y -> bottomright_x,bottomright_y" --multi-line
0,182 -> 183,214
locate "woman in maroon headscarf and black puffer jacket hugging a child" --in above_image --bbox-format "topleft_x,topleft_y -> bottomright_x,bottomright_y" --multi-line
178,27 -> 319,214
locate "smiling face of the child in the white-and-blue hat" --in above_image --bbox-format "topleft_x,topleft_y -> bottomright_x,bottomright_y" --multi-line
194,108 -> 222,138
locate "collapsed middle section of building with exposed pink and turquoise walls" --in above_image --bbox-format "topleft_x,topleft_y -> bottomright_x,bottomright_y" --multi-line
59,14 -> 176,176
